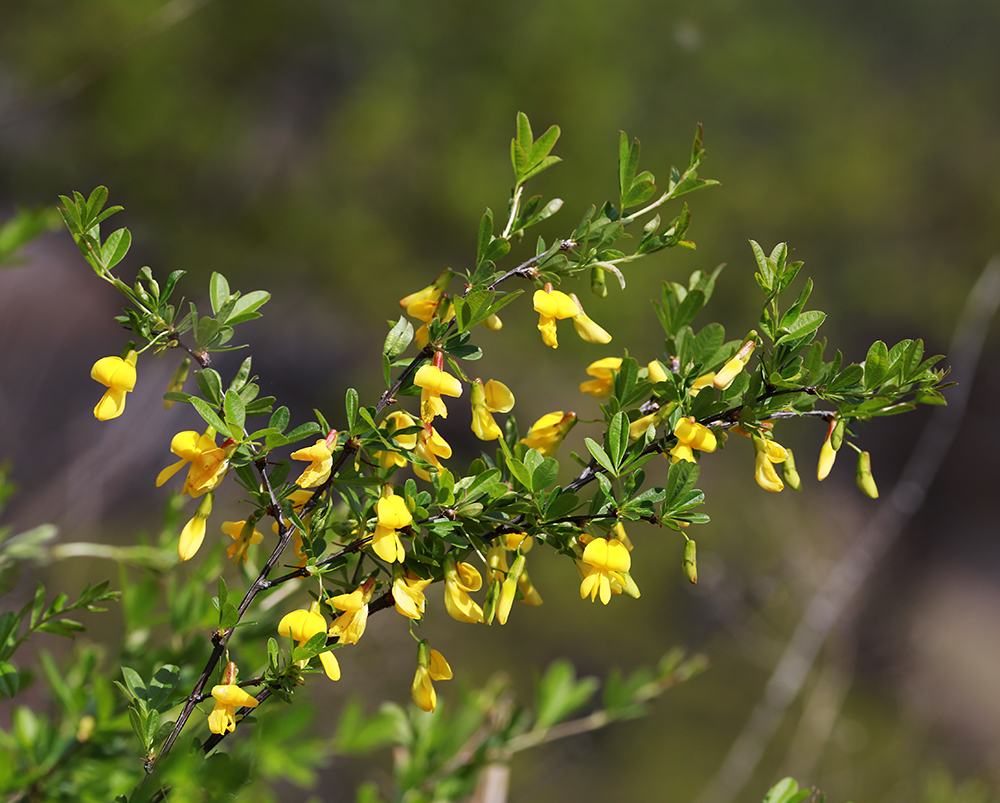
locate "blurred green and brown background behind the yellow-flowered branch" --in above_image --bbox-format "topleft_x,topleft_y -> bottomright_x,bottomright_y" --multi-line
0,0 -> 1000,803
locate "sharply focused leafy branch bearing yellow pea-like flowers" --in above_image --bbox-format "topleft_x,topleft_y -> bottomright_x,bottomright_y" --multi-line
0,114 -> 945,794
